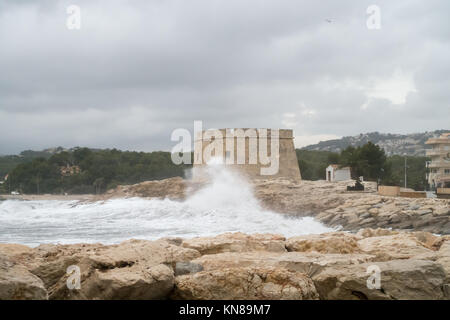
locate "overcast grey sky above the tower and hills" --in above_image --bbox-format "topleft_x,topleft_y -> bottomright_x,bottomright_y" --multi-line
0,0 -> 450,154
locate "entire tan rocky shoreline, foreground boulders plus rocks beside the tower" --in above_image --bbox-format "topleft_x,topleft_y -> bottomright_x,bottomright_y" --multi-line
0,178 -> 450,300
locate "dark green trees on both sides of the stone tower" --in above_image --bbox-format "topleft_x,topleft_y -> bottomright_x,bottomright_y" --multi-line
0,142 -> 429,194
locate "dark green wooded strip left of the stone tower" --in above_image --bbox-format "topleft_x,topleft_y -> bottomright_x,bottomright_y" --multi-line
2,148 -> 185,194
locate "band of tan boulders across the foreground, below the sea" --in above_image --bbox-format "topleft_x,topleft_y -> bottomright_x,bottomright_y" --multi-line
0,229 -> 450,300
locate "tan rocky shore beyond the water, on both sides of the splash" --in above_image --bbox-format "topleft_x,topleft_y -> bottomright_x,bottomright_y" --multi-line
102,178 -> 450,234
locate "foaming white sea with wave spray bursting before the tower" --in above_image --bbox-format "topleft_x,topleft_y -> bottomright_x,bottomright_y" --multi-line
0,164 -> 332,246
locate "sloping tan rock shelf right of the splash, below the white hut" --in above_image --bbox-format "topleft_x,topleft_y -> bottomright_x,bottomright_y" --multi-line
255,181 -> 450,234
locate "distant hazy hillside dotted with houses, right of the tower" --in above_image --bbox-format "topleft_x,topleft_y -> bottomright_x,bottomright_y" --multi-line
302,130 -> 450,156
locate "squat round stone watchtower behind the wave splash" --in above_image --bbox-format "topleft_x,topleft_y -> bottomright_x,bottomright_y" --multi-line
194,128 -> 301,181
